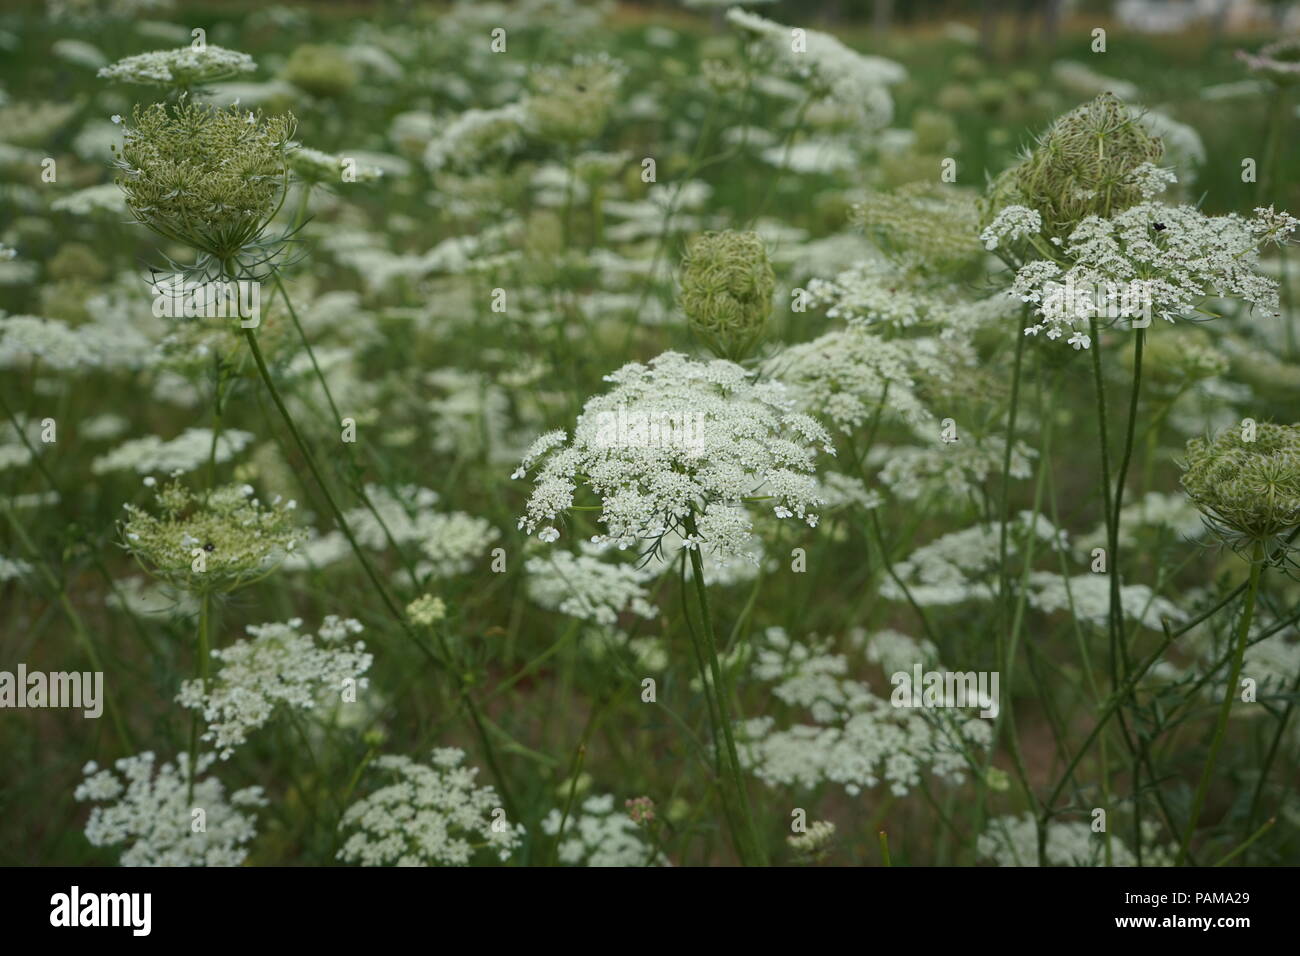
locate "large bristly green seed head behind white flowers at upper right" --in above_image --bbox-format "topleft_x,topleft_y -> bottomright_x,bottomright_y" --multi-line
982,92 -> 1165,238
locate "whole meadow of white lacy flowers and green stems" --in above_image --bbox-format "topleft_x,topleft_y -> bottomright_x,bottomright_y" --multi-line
0,0 -> 1300,866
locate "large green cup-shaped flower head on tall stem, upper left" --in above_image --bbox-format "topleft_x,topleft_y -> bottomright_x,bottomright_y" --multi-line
114,100 -> 295,265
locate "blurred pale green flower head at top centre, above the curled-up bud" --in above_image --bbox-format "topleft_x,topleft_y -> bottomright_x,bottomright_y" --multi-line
528,55 -> 625,144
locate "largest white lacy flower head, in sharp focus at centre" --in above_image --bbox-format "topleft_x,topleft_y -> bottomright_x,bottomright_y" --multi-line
514,351 -> 835,557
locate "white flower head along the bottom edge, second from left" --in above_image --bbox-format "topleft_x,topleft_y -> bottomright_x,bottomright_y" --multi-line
338,747 -> 524,866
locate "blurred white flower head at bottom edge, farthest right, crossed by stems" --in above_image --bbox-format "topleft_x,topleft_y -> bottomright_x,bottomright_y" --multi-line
975,812 -> 1174,866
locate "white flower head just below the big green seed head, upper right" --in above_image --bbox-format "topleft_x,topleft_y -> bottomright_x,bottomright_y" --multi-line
1010,203 -> 1300,349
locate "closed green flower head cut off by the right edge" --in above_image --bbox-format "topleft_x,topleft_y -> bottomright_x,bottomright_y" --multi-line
1183,421 -> 1300,548
